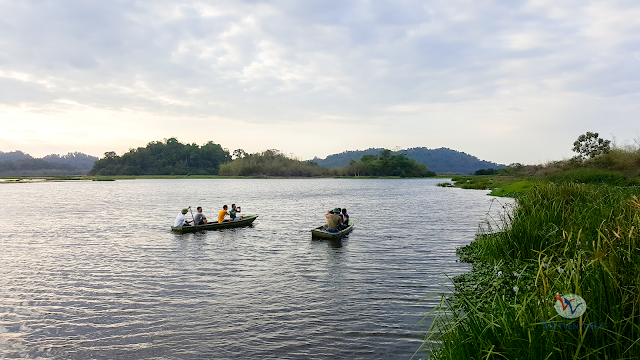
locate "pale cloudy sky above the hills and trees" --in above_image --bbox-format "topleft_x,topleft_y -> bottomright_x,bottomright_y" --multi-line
0,0 -> 640,164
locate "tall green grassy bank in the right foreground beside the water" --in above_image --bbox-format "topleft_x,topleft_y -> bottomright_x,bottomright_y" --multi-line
424,181 -> 640,359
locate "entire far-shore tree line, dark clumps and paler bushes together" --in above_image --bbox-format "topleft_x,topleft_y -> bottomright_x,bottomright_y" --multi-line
89,138 -> 435,177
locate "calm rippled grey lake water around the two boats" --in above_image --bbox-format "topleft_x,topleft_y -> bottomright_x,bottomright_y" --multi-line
0,179 -> 507,359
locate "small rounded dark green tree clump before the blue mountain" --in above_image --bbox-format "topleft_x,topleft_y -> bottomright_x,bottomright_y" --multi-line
346,150 -> 436,177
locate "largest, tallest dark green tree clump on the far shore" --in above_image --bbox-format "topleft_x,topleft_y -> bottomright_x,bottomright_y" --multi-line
89,138 -> 231,176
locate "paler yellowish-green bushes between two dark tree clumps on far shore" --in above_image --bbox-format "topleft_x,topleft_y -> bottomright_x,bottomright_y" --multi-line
220,149 -> 328,177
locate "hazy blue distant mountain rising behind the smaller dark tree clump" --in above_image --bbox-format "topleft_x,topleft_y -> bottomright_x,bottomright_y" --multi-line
311,147 -> 506,174
